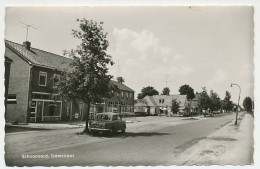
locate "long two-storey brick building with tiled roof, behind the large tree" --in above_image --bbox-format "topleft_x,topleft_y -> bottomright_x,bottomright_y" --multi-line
5,40 -> 134,123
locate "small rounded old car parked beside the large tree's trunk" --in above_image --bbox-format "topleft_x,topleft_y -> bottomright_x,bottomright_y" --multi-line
89,112 -> 126,134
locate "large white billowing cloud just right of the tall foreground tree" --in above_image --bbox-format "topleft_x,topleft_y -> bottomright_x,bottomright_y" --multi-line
108,28 -> 193,94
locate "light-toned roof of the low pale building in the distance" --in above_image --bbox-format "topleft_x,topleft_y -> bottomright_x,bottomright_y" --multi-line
144,95 -> 187,107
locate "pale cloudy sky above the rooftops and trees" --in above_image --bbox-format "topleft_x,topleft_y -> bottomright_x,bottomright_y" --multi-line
5,6 -> 254,104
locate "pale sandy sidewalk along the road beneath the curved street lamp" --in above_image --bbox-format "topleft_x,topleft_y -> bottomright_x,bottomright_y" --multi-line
174,113 -> 254,165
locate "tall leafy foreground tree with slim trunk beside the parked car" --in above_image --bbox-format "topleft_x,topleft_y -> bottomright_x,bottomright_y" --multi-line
55,19 -> 117,133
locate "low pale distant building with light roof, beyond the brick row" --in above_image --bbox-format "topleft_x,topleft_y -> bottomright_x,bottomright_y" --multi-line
135,95 -> 188,115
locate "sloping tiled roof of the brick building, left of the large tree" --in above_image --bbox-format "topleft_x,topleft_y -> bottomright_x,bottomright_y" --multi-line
5,40 -> 72,70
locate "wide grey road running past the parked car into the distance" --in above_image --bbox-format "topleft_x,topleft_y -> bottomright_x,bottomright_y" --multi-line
6,114 -> 235,166
